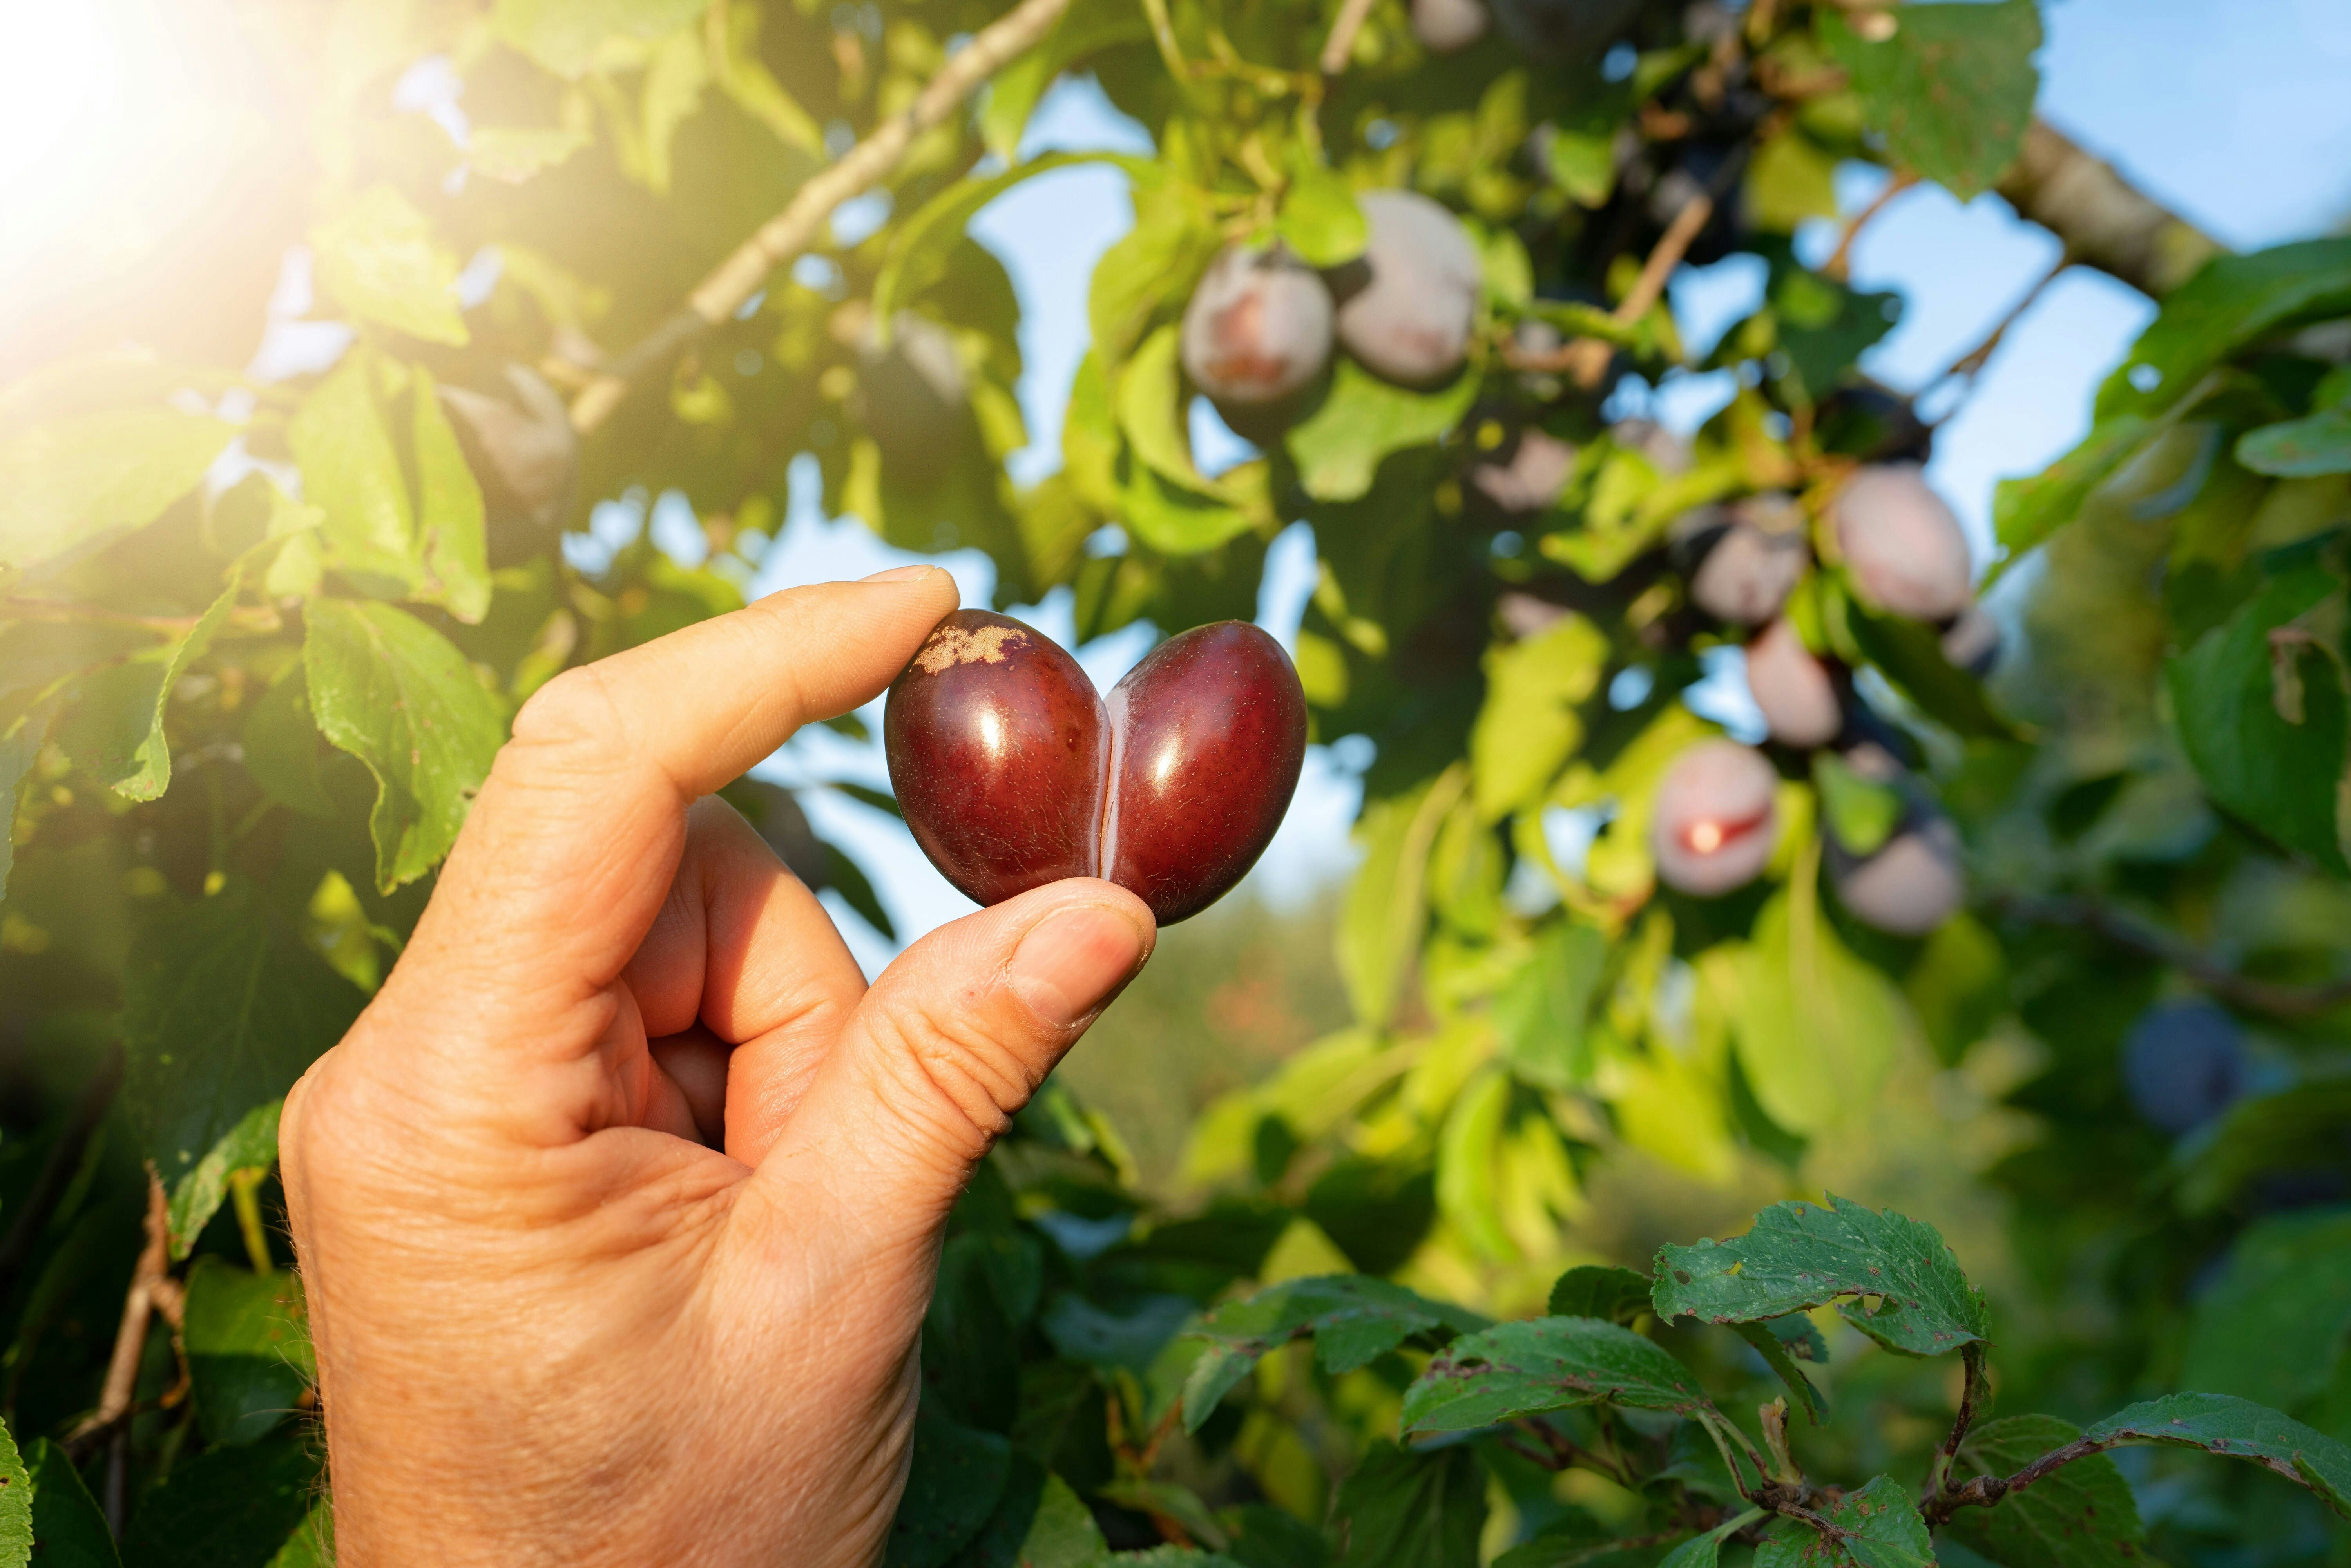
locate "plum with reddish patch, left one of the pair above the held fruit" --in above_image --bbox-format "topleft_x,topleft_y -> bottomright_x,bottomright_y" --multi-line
1183,244 -> 1333,421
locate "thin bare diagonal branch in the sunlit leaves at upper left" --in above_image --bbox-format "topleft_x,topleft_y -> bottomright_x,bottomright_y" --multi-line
571,0 -> 1070,433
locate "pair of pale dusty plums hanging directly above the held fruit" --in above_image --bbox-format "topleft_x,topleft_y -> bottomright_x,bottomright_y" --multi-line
1183,190 -> 1483,440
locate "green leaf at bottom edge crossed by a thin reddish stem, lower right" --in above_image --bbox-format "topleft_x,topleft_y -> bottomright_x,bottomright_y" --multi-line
1944,1415 -> 2146,1568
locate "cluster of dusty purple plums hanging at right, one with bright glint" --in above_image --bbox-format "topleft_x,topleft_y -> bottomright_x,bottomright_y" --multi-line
1650,463 -> 1998,936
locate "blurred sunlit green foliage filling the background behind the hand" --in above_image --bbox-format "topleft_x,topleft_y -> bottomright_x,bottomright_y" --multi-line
0,0 -> 2351,1568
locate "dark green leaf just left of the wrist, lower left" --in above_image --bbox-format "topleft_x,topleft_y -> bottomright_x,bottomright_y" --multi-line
181,1258 -> 317,1446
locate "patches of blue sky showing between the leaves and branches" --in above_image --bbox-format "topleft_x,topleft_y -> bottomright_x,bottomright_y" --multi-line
759,0 -> 2351,971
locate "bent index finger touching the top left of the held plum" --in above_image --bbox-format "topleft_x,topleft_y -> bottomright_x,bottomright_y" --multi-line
411,567 -> 957,1006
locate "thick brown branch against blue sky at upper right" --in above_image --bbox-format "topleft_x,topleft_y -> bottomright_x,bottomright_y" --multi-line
1996,120 -> 2229,299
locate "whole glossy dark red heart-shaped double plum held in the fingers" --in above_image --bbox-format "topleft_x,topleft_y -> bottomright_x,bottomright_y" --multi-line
882,609 -> 1307,926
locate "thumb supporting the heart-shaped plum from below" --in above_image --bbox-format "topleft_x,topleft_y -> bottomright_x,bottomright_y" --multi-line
757,879 -> 1157,1246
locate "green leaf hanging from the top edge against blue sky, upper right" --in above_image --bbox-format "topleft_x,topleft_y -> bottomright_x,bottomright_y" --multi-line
1817,0 -> 2041,202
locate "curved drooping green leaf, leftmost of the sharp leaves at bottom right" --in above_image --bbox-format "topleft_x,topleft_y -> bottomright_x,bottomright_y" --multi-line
1183,1274 -> 1486,1432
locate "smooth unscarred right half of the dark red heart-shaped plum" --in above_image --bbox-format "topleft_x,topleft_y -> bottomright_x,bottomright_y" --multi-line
1103,621 -> 1307,926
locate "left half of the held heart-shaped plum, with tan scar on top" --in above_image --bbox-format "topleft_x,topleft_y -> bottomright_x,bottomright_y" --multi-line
882,609 -> 1110,903
